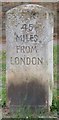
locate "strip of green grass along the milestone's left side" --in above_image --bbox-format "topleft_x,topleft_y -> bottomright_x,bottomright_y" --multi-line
1,51 -> 7,107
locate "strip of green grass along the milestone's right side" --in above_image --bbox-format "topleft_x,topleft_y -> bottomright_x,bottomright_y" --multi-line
51,45 -> 59,115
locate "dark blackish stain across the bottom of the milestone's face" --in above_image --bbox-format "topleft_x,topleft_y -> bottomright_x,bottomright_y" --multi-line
8,80 -> 48,106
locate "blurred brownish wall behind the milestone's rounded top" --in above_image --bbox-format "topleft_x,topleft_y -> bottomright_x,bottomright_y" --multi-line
0,2 -> 59,43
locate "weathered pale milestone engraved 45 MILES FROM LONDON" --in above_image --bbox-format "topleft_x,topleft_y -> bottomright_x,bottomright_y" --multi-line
6,4 -> 53,108
